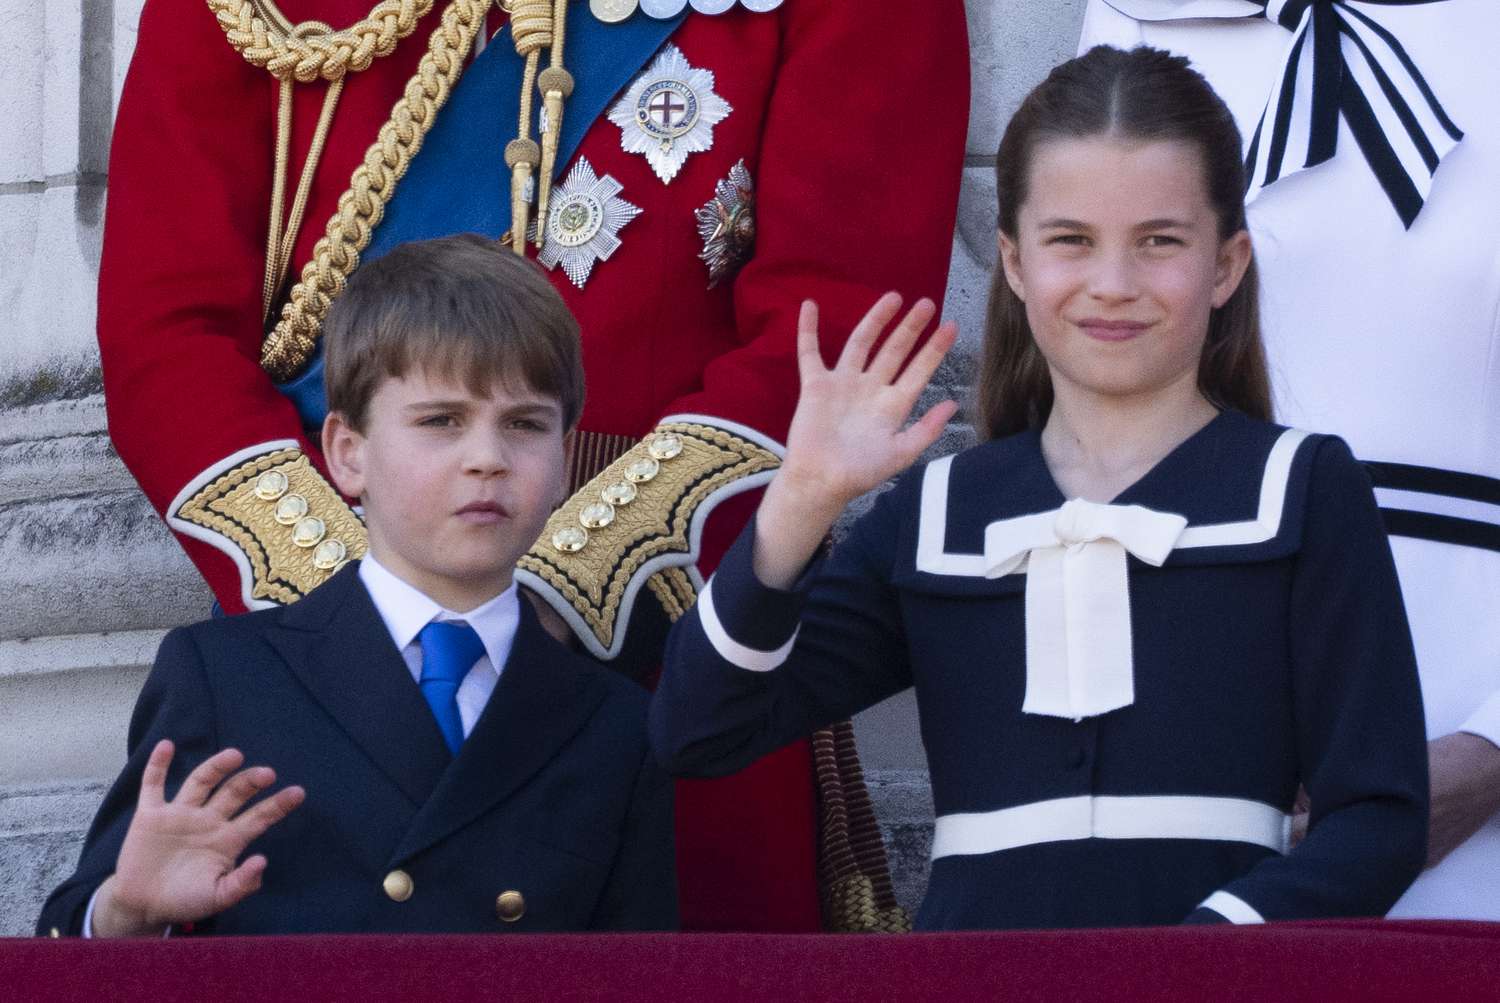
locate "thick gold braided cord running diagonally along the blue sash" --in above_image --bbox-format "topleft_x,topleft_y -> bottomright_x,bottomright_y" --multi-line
261,0 -> 491,382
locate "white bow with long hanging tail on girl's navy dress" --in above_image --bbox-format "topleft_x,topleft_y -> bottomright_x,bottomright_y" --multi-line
984,498 -> 1188,721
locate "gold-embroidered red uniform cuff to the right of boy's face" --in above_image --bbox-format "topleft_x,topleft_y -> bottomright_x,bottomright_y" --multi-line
516,415 -> 782,658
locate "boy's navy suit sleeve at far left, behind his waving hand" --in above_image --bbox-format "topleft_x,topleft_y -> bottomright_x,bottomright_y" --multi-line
36,628 -> 219,937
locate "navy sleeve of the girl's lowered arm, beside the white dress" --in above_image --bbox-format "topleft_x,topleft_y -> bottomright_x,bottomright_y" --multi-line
1194,438 -> 1428,919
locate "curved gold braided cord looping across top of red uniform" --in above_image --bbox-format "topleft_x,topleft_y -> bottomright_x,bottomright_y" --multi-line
207,0 -> 432,84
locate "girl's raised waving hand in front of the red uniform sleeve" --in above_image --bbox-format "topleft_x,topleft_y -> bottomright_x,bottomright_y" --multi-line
755,292 -> 959,588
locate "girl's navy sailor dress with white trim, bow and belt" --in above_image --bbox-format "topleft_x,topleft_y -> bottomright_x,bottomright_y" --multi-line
651,411 -> 1427,930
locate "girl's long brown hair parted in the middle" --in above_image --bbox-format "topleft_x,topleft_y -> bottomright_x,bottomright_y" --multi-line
974,45 -> 1271,438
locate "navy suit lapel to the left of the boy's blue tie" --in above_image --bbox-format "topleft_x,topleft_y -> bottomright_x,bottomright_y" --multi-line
270,562 -> 452,805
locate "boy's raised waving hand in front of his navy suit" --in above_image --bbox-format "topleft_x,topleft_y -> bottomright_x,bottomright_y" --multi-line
93,739 -> 305,937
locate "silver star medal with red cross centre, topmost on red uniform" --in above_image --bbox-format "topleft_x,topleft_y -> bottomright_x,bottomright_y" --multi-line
609,42 -> 734,181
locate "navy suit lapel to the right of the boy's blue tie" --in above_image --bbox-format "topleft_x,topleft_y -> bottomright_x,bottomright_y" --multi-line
393,600 -> 618,861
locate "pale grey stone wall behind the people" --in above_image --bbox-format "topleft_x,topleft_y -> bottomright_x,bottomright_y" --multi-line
0,0 -> 1083,936
